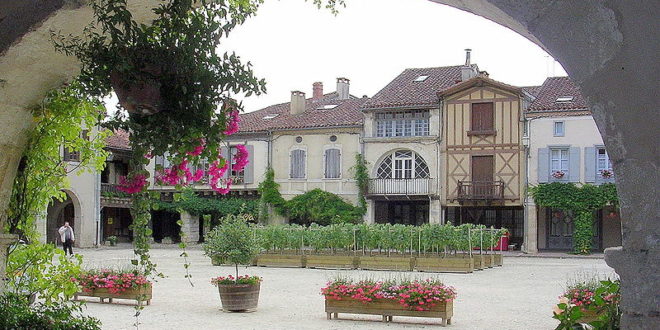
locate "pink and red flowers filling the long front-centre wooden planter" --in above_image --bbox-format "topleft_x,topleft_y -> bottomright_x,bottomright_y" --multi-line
321,279 -> 456,311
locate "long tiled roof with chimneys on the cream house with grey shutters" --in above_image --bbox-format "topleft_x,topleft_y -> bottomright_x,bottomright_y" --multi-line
240,93 -> 368,133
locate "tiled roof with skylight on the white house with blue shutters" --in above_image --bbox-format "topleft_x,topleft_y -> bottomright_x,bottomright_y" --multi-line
527,77 -> 589,116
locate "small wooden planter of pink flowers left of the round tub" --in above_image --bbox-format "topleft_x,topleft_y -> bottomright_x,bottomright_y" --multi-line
71,269 -> 152,305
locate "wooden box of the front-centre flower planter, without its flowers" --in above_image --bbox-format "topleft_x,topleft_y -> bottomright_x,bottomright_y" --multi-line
325,298 -> 454,325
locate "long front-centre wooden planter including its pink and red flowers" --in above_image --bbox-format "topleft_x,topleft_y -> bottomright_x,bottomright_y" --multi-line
321,279 -> 456,325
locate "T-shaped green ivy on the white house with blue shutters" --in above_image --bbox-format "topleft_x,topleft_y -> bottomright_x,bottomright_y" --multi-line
530,182 -> 619,254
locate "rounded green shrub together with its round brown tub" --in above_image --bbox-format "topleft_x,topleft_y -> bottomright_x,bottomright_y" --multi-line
203,215 -> 261,312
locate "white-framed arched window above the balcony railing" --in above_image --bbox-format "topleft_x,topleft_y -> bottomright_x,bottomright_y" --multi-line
376,150 -> 430,179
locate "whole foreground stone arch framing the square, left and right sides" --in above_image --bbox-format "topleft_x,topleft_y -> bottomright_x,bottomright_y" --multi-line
0,0 -> 660,329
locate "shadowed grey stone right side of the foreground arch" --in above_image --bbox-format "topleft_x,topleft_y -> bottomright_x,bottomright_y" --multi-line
431,0 -> 660,329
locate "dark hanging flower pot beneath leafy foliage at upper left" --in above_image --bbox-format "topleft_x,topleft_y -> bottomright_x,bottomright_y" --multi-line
110,71 -> 164,115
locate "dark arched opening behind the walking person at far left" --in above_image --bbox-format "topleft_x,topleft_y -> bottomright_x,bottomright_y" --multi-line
45,190 -> 82,244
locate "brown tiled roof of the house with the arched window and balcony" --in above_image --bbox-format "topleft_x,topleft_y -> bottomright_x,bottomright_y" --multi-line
362,64 -> 478,109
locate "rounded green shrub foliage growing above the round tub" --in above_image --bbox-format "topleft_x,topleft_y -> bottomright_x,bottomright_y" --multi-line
203,215 -> 259,277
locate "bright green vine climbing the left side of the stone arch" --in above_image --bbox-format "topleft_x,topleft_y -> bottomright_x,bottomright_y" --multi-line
4,82 -> 109,241
